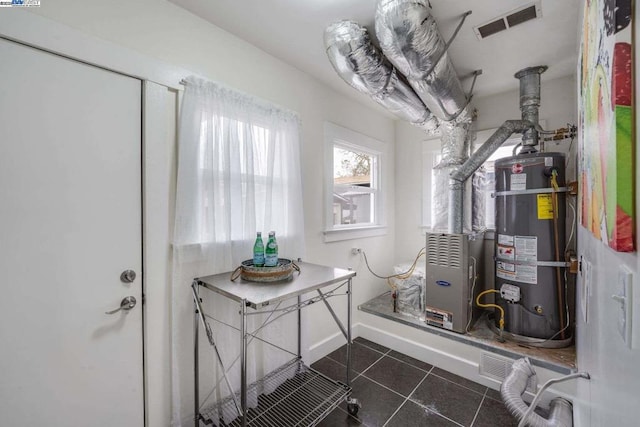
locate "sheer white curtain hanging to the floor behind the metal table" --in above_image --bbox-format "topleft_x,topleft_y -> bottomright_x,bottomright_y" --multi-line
171,77 -> 304,426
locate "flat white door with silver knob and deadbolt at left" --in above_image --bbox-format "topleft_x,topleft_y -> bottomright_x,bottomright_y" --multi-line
0,39 -> 144,427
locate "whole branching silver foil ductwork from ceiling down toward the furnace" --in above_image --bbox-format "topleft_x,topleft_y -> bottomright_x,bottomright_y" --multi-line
324,0 -> 530,233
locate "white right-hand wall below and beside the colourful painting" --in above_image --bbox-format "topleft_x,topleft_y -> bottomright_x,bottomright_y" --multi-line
574,4 -> 640,427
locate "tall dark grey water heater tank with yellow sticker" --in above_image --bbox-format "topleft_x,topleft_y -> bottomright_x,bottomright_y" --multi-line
495,153 -> 568,340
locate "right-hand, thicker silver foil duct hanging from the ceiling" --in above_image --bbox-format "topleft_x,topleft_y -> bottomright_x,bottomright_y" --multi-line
375,0 -> 468,121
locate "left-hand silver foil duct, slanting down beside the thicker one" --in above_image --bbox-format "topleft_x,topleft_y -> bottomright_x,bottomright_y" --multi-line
324,20 -> 438,133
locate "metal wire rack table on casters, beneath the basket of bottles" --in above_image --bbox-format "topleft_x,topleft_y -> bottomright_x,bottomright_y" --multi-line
192,262 -> 360,427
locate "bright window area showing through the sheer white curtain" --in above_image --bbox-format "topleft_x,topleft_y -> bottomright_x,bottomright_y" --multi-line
196,117 -> 278,243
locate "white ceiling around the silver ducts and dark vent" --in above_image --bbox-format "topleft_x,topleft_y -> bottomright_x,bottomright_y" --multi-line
170,0 -> 580,112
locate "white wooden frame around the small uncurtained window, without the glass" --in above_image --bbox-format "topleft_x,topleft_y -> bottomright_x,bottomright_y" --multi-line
323,122 -> 388,242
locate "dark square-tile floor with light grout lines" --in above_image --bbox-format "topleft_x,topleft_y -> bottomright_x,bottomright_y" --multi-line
311,338 -> 518,427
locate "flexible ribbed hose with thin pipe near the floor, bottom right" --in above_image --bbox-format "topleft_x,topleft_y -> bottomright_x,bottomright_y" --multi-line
500,358 -> 589,427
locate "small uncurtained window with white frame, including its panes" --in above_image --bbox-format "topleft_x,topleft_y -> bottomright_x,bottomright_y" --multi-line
324,123 -> 386,241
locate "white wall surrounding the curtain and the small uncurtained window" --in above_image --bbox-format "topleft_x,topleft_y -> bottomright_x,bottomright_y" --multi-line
13,0 -> 395,426
